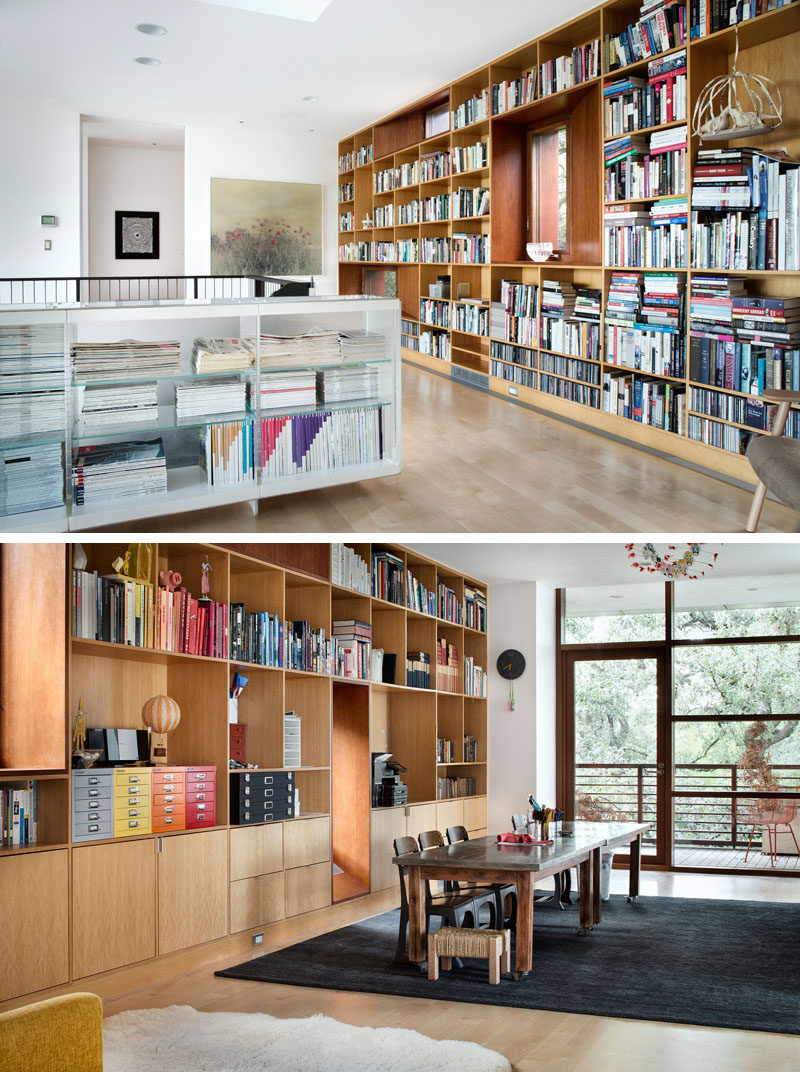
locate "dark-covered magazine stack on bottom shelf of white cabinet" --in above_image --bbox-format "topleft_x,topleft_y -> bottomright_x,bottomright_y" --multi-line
72,438 -> 166,506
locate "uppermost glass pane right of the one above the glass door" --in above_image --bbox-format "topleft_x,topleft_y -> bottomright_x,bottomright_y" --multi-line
675,564 -> 800,640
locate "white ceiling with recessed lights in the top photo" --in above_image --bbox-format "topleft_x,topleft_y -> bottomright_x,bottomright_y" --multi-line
0,0 -> 592,138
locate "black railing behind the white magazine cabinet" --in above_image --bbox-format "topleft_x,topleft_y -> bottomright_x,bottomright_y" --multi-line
0,276 -> 314,306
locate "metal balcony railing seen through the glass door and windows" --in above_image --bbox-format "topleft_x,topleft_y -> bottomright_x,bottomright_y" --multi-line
575,763 -> 800,849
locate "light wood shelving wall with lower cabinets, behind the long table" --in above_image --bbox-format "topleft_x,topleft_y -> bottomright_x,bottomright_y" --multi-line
0,542 -> 488,1001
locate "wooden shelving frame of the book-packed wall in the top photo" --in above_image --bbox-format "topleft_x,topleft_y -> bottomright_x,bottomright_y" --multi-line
339,0 -> 800,482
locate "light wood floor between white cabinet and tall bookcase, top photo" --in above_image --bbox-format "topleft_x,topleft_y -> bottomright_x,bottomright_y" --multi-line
101,366 -> 800,533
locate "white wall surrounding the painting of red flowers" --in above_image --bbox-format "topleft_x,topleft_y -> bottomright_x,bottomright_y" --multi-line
186,124 -> 338,294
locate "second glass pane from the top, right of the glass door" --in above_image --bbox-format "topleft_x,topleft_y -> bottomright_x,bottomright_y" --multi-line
672,643 -> 800,718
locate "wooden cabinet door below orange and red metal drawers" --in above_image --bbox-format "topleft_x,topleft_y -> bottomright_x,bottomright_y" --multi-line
158,830 -> 227,955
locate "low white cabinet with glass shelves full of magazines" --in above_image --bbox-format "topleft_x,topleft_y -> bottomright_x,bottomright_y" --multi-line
0,297 -> 401,531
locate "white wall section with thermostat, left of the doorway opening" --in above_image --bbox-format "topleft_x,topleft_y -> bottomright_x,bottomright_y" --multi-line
0,99 -> 80,277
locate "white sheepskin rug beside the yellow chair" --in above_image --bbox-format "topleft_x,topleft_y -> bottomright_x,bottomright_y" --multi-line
103,1006 -> 512,1072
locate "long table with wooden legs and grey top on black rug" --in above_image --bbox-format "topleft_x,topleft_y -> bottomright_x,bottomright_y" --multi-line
394,821 -> 649,979
